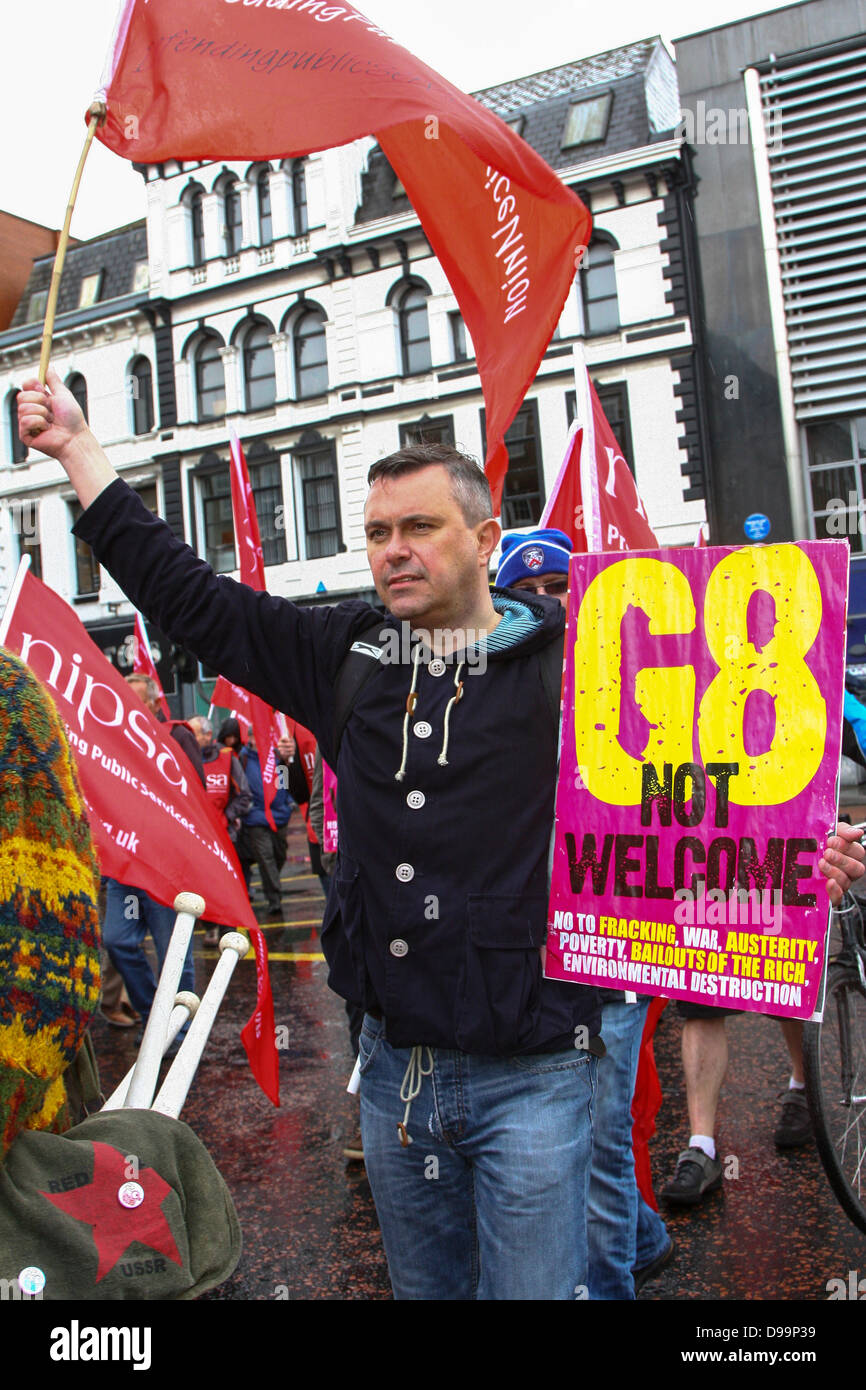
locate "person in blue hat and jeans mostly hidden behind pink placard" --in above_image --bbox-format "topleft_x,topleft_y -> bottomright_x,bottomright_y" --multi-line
496,528 -> 674,1300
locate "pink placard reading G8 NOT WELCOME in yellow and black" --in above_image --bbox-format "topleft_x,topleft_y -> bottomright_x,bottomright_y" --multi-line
545,541 -> 848,1019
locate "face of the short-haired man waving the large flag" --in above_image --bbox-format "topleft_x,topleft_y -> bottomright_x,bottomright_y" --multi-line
364,464 -> 496,628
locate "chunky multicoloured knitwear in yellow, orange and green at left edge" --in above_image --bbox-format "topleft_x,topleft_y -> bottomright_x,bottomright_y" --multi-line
0,649 -> 100,1159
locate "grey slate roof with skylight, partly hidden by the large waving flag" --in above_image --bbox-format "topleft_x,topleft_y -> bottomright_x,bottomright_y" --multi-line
354,39 -> 677,222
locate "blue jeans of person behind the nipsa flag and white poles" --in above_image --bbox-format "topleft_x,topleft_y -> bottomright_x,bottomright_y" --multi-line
103,878 -> 196,1020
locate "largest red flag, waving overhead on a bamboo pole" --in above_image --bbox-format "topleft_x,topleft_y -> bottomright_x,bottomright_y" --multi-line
97,0 -> 591,512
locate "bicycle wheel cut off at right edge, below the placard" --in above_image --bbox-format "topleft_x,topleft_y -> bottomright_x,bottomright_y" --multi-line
803,966 -> 866,1232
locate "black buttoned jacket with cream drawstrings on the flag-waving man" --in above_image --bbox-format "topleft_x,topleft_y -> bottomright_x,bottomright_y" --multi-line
75,480 -> 601,1055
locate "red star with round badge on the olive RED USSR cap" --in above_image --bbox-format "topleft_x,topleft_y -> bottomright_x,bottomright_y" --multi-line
42,1143 -> 183,1283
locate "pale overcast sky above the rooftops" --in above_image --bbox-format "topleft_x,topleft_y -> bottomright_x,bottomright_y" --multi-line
0,0 -> 800,238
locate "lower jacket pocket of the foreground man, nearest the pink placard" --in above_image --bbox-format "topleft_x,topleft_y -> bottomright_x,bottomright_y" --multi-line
456,895 -> 548,1055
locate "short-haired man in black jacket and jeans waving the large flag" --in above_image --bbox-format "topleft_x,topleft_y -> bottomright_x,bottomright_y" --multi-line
18,373 -> 865,1300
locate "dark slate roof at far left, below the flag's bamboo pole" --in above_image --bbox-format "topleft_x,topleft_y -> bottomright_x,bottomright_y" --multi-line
10,218 -> 147,329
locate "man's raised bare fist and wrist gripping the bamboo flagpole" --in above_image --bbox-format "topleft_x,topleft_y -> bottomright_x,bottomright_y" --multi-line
18,368 -> 117,507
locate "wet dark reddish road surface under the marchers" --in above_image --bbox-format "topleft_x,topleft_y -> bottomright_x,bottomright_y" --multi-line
93,816 -> 866,1301
